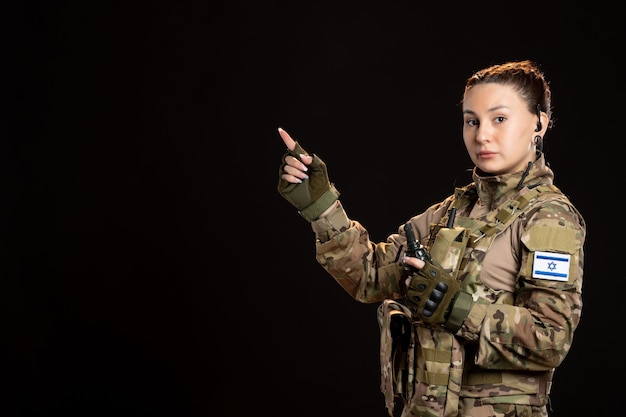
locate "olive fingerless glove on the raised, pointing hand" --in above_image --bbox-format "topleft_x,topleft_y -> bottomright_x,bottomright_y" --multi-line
278,142 -> 339,221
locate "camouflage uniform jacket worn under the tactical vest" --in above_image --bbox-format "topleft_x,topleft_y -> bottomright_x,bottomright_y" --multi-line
311,154 -> 586,415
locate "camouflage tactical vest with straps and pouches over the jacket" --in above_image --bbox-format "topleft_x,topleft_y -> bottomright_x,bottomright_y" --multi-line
377,185 -> 569,417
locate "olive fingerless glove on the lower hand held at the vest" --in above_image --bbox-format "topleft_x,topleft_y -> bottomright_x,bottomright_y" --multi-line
406,262 -> 473,333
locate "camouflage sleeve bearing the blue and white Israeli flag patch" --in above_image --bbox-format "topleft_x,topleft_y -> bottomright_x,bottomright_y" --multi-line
461,198 -> 586,370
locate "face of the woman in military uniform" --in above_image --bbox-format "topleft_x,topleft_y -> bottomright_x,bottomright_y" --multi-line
463,83 -> 547,175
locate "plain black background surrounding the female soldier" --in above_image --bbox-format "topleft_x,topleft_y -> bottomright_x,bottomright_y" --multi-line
0,1 -> 624,417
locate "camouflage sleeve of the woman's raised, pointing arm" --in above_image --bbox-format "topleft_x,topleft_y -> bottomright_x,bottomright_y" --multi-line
311,200 -> 446,303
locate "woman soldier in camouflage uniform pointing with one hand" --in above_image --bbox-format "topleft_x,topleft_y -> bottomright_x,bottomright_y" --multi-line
278,61 -> 586,417
